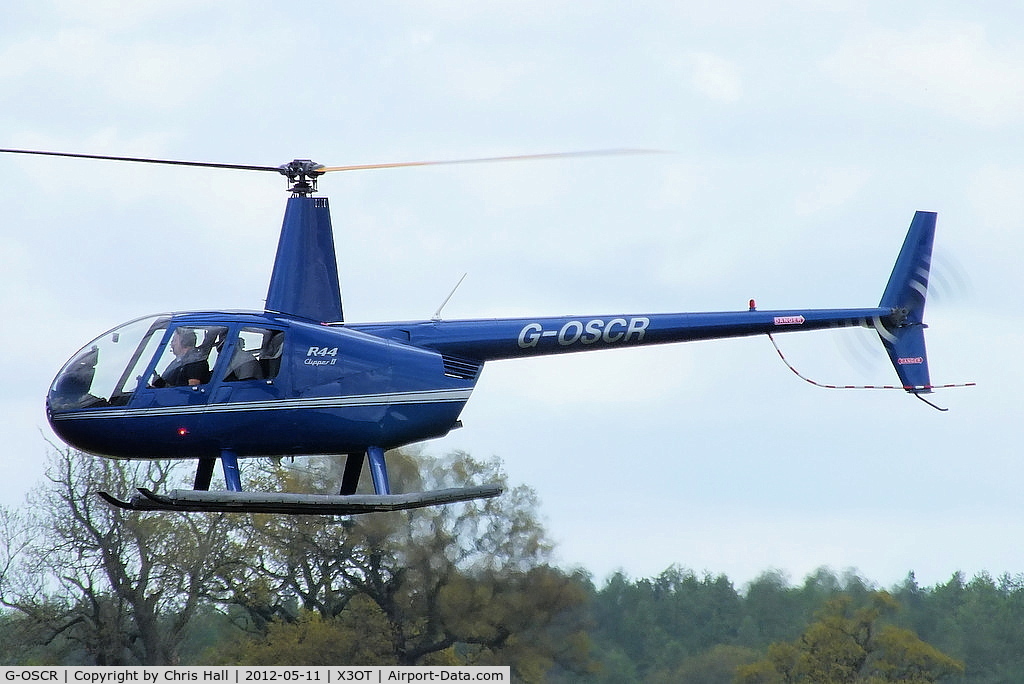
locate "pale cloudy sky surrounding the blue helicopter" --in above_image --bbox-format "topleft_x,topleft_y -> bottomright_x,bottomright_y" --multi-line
0,0 -> 1024,587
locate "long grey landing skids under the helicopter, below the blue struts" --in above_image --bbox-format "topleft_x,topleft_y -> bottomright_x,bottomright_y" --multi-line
99,484 -> 502,515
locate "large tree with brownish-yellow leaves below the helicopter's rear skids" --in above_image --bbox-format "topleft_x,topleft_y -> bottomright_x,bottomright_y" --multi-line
214,452 -> 589,681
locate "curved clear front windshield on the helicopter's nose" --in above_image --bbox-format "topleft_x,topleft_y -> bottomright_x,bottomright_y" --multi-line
49,315 -> 170,411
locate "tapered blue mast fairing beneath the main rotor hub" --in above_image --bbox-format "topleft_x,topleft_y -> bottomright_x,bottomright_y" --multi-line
266,192 -> 343,323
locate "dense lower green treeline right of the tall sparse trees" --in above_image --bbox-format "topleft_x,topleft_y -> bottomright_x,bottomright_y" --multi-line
589,566 -> 1024,684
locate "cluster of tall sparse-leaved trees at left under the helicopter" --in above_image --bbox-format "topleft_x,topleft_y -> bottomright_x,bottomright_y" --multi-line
0,451 -> 590,681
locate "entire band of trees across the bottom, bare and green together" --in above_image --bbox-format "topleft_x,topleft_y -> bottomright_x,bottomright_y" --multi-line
0,450 -> 1024,684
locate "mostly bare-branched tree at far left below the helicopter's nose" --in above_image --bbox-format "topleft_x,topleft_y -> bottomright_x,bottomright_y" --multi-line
0,448 -> 247,665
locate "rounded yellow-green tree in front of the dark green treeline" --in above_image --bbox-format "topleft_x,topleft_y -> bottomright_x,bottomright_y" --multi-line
737,592 -> 964,684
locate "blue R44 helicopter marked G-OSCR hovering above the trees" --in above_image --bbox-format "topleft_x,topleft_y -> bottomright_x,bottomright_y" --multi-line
0,149 -> 954,515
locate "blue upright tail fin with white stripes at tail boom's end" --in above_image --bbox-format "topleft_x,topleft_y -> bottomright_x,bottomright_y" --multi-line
874,211 -> 936,394
